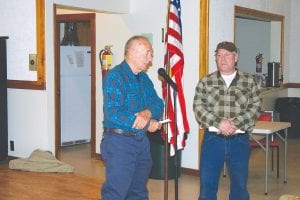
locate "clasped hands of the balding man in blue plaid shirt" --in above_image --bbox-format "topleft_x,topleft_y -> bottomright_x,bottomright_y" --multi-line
132,109 -> 161,132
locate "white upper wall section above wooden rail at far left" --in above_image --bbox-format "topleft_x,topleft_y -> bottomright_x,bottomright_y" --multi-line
0,0 -> 37,80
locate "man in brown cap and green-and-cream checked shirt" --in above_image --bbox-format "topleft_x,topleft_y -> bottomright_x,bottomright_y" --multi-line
193,41 -> 261,200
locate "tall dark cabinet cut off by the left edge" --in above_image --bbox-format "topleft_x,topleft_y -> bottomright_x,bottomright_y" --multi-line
0,36 -> 8,160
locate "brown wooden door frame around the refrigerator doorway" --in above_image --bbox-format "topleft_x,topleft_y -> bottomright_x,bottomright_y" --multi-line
54,9 -> 96,159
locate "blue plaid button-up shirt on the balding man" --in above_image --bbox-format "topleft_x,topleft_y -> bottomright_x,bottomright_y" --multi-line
102,61 -> 164,132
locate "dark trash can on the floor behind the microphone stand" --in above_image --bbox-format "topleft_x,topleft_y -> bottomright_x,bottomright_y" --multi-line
147,131 -> 181,180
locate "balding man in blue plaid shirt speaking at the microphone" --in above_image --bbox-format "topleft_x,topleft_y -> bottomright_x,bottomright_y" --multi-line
100,36 -> 164,200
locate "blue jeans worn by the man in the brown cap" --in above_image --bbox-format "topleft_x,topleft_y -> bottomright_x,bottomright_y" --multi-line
199,131 -> 250,200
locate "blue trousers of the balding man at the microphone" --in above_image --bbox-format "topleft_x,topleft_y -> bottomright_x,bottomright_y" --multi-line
100,132 -> 152,200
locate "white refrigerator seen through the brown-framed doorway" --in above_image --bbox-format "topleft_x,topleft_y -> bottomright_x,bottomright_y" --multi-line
60,46 -> 91,146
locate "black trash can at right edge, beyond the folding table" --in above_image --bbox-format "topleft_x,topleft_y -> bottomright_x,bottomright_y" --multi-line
275,97 -> 300,138
